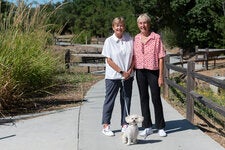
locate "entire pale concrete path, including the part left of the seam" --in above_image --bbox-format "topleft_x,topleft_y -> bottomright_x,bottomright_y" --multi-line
0,80 -> 224,150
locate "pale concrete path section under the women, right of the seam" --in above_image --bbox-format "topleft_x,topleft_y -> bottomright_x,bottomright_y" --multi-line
78,80 -> 224,150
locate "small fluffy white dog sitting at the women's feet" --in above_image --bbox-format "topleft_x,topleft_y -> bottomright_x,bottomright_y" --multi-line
122,114 -> 144,145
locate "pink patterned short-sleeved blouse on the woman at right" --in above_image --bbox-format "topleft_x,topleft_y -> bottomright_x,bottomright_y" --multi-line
134,32 -> 166,70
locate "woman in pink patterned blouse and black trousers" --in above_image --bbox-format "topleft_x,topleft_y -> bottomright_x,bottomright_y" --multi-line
134,14 -> 166,137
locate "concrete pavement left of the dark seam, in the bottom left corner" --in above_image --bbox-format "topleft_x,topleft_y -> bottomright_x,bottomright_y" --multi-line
0,107 -> 79,150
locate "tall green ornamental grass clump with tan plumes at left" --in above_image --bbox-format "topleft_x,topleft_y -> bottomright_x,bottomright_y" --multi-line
0,2 -> 58,109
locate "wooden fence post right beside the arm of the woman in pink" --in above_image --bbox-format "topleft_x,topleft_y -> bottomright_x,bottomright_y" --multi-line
163,55 -> 170,99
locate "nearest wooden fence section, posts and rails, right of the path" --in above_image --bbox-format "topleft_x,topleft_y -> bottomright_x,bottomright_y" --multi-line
163,54 -> 225,123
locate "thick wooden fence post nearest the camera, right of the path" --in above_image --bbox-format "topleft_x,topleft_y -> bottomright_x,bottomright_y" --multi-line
186,61 -> 195,123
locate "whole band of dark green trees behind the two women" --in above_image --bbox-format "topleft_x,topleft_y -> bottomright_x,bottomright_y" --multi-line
1,0 -> 225,49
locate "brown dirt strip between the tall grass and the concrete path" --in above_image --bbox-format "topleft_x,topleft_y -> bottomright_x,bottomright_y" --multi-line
1,75 -> 104,117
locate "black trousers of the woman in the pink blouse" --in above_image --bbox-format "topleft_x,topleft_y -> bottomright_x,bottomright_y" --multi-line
136,69 -> 165,129
